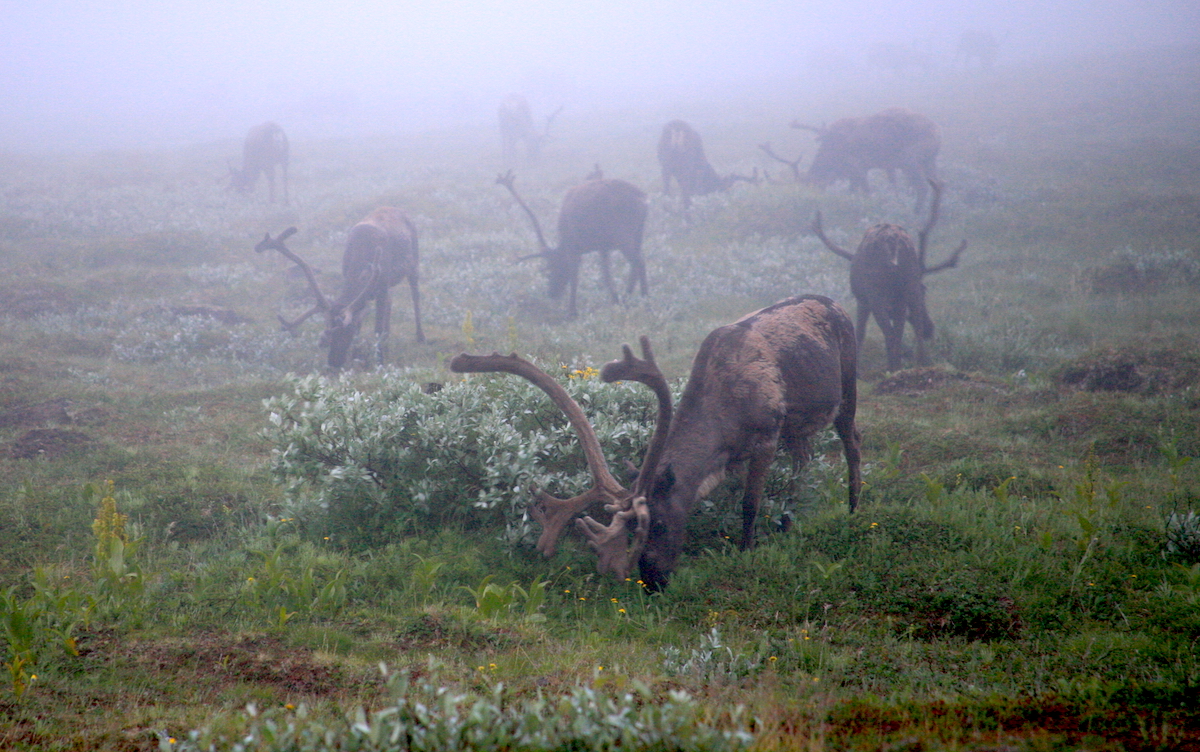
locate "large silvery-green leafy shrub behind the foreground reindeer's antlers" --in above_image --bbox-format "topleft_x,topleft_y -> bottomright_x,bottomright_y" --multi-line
265,369 -> 656,547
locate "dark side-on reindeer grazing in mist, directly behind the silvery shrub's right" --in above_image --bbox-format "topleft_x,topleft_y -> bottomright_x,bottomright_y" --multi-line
496,170 -> 648,318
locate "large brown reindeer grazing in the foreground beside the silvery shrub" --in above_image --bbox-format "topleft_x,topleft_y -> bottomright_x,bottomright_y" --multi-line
450,295 -> 862,590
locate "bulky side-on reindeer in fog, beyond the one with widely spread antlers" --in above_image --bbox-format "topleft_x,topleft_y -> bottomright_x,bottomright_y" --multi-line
792,107 -> 942,213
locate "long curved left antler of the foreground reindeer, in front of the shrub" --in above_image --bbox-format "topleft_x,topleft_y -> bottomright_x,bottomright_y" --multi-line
450,353 -> 628,557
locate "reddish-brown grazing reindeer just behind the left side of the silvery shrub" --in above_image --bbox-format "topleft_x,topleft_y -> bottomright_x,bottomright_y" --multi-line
254,206 -> 425,369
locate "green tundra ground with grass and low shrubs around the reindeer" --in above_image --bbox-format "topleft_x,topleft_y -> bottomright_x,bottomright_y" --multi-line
0,52 -> 1200,751
